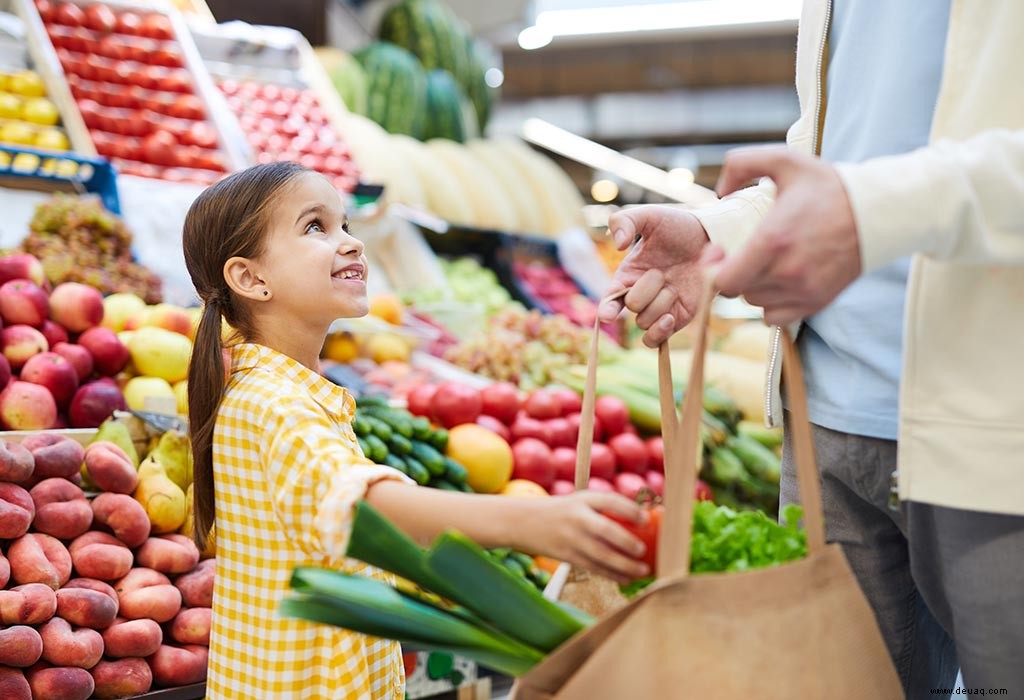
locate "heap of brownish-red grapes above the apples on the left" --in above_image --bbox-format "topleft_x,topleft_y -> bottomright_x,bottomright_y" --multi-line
22,194 -> 163,304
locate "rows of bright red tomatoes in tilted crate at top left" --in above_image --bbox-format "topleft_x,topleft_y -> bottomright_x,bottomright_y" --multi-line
36,0 -> 230,184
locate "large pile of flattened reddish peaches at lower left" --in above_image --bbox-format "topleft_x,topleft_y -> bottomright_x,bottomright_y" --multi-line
0,423 -> 215,700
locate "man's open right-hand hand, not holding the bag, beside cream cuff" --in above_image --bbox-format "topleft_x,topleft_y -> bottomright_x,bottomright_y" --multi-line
715,146 -> 861,325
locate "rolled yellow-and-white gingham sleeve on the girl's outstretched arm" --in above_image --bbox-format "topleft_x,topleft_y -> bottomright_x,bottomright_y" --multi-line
263,398 -> 415,561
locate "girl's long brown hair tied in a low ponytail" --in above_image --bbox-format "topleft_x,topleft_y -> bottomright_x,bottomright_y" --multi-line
182,163 -> 309,550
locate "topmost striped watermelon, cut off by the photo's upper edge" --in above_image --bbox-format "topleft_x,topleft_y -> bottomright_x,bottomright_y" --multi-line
377,0 -> 469,88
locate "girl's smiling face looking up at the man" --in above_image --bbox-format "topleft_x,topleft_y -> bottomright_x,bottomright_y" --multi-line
258,173 -> 369,330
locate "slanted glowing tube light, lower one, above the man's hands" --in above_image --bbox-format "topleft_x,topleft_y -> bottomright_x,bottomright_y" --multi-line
522,118 -> 718,207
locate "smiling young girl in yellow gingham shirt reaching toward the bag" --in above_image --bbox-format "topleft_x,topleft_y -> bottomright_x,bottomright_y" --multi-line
184,163 -> 647,700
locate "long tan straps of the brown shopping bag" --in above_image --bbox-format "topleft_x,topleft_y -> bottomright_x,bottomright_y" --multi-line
575,277 -> 825,578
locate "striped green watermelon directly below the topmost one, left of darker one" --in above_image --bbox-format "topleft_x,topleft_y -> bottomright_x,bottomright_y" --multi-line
354,41 -> 427,138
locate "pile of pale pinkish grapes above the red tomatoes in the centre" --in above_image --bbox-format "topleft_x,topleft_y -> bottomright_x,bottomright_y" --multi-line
444,307 -> 617,391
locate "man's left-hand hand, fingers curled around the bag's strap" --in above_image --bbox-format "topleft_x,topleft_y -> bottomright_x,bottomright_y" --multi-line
600,206 -> 708,348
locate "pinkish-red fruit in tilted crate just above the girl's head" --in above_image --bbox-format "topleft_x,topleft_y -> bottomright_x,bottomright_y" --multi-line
218,80 -> 359,192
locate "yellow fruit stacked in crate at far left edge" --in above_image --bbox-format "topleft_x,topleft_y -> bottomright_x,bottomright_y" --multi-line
0,71 -> 70,150
